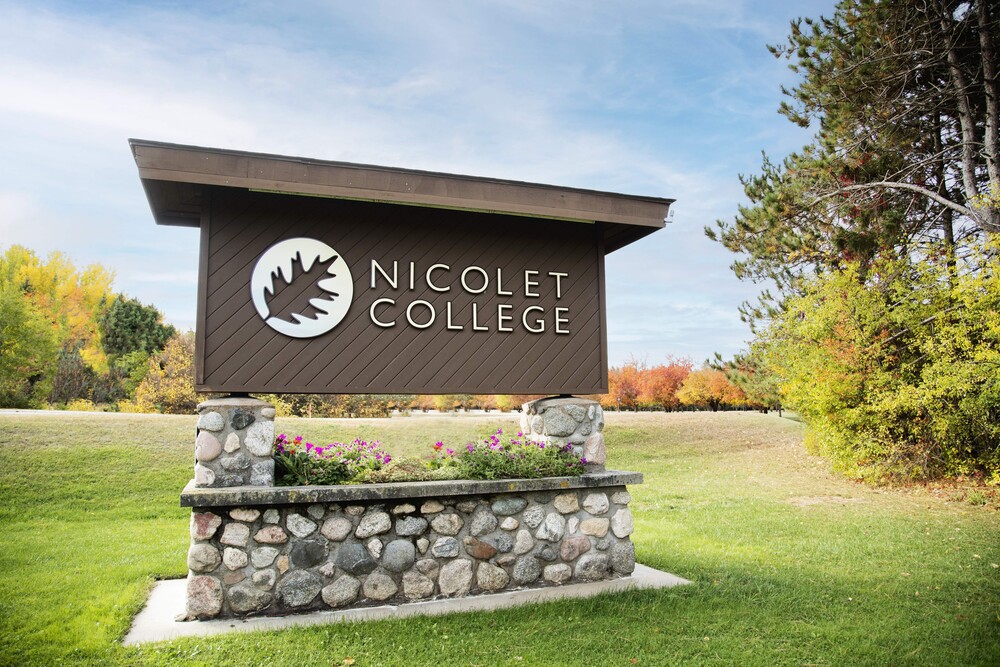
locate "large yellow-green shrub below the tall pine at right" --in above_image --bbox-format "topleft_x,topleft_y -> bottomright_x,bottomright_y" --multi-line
754,247 -> 1000,484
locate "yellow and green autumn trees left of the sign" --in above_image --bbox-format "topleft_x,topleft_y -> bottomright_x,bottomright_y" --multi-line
0,245 -> 189,409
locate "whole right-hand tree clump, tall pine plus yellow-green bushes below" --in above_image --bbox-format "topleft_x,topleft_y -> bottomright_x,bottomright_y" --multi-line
706,0 -> 1000,484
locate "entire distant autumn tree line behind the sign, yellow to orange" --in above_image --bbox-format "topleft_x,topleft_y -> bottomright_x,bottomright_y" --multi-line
0,245 -> 752,417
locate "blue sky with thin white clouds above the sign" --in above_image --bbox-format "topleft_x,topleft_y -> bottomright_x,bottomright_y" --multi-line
0,0 -> 833,365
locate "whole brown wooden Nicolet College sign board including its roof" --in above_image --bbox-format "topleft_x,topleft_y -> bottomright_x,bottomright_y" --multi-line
127,142 -> 669,394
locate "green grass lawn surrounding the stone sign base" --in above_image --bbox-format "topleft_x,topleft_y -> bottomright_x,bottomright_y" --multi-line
0,413 -> 1000,667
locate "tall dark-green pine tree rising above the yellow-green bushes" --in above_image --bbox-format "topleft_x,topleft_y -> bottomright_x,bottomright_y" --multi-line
706,0 -> 1000,319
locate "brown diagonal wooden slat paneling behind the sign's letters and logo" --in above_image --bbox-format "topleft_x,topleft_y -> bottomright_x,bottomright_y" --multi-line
198,187 -> 607,394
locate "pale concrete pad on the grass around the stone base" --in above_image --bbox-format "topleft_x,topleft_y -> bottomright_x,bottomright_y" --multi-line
124,563 -> 691,646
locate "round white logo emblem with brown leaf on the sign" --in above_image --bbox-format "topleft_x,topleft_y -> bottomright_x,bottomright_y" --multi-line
250,238 -> 354,338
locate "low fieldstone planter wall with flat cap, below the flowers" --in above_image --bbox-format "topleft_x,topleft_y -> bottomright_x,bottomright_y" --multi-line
182,480 -> 641,619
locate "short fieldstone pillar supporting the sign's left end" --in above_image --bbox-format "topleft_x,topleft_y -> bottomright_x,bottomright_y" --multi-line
194,396 -> 274,487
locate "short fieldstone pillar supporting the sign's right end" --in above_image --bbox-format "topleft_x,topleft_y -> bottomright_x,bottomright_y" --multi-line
521,396 -> 607,472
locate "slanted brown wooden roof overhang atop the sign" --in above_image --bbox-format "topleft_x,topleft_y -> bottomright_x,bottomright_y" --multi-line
129,139 -> 674,252
